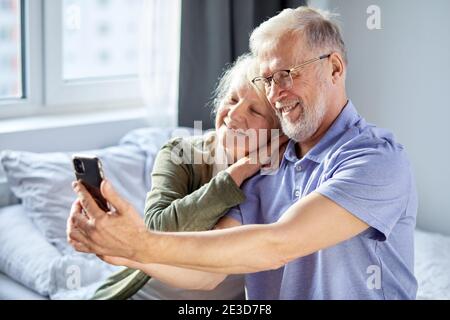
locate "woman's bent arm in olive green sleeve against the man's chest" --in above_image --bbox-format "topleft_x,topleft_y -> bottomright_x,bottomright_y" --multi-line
144,139 -> 248,231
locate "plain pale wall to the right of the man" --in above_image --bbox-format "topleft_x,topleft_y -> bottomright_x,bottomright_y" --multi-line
309,0 -> 450,234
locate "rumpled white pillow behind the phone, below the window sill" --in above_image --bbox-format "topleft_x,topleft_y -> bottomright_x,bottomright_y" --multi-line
0,128 -> 173,253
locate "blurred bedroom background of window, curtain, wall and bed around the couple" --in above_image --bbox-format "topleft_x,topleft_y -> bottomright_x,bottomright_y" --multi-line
0,0 -> 450,299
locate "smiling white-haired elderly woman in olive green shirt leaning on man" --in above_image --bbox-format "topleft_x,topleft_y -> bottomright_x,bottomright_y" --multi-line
68,55 -> 287,299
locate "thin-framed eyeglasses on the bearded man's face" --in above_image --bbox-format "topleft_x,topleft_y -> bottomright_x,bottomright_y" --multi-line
252,53 -> 331,94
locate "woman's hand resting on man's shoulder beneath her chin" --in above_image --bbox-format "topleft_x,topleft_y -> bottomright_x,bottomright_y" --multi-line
226,135 -> 289,187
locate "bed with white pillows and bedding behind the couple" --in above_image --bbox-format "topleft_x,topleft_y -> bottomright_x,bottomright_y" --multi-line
0,128 -> 450,300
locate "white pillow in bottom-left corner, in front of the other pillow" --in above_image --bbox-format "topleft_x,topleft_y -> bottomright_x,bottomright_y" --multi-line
0,205 -> 119,300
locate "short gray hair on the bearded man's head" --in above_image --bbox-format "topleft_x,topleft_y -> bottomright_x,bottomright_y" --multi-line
250,7 -> 347,63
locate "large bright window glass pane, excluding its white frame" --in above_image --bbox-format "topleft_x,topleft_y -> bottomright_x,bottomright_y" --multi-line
63,0 -> 143,81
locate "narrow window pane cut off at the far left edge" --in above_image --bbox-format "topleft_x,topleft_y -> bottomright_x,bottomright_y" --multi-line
0,0 -> 23,99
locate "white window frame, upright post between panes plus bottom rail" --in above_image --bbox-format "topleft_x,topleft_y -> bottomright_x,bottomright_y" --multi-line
0,0 -> 146,121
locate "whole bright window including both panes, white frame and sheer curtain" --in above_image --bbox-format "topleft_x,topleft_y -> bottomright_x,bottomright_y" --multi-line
0,0 -> 181,118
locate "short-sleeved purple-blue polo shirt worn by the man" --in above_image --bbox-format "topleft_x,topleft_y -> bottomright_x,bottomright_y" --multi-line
228,102 -> 417,299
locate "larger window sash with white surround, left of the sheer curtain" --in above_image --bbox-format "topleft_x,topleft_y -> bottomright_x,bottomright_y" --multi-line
44,0 -> 143,109
